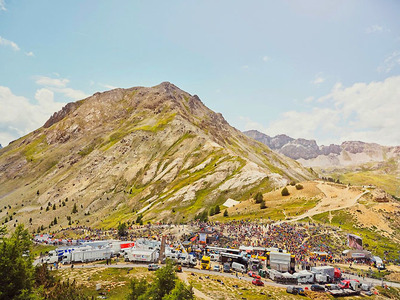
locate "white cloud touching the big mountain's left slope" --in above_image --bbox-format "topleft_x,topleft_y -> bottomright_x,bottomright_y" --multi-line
0,86 -> 66,146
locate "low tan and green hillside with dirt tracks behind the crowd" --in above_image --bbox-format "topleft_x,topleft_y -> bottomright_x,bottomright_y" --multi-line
211,181 -> 400,259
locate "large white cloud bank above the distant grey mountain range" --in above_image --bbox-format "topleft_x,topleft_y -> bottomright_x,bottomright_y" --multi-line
242,76 -> 400,145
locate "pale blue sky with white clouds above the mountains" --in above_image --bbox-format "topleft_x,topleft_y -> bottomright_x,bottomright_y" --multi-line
0,0 -> 400,146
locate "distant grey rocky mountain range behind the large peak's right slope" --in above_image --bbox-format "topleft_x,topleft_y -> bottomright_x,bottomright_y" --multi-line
244,130 -> 400,196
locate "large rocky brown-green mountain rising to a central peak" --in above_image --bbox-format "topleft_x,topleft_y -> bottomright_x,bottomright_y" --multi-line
0,82 -> 315,228
